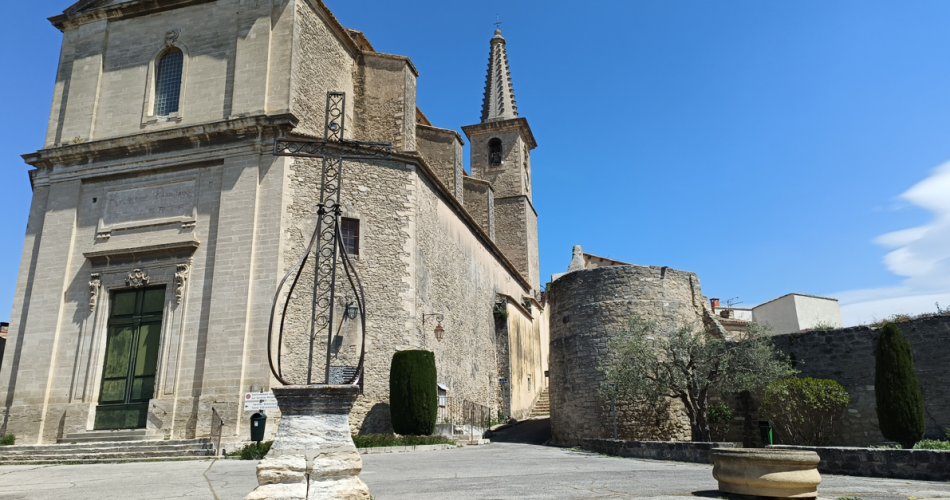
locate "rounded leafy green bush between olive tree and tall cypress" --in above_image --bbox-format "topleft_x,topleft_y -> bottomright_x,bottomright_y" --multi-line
759,378 -> 851,446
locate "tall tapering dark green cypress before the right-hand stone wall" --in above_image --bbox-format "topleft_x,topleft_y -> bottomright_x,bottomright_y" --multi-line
874,323 -> 925,448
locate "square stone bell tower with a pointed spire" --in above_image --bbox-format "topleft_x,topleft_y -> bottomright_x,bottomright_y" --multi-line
462,29 -> 541,291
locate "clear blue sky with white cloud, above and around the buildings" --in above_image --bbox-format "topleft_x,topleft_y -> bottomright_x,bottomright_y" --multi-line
0,0 -> 950,324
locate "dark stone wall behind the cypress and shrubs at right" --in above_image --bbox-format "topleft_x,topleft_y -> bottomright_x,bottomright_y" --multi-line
729,316 -> 950,446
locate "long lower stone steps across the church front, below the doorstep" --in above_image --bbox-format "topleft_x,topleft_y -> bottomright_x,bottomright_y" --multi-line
0,439 -> 214,464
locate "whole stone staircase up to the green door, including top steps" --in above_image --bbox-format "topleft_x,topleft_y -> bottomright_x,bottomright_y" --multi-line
0,430 -> 215,465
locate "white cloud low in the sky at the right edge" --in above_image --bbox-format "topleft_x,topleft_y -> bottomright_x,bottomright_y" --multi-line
834,162 -> 950,325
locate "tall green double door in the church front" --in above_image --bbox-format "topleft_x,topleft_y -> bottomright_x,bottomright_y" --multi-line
95,287 -> 165,429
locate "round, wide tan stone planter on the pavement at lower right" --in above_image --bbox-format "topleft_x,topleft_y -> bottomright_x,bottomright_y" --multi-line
710,449 -> 821,498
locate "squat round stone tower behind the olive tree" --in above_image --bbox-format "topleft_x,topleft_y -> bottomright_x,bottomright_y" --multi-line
548,265 -> 715,445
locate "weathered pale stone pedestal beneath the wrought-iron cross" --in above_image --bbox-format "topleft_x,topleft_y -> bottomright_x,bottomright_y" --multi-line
245,385 -> 370,500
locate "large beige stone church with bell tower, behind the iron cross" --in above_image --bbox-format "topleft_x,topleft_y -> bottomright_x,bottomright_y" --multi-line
0,0 -> 548,444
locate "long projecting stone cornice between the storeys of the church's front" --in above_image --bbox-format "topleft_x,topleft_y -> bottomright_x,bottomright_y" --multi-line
22,113 -> 298,168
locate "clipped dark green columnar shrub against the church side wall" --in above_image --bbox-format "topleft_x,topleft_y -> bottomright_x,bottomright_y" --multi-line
389,351 -> 439,436
